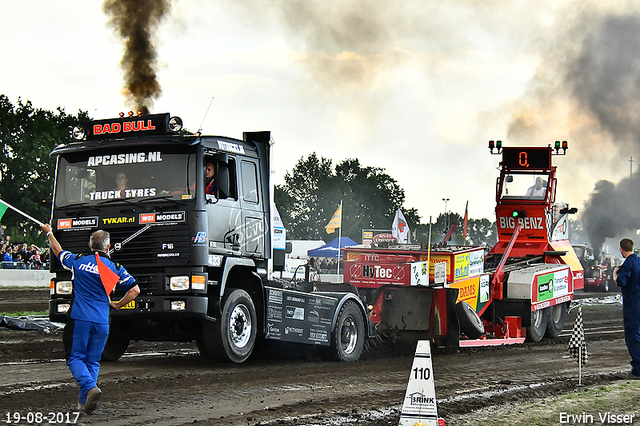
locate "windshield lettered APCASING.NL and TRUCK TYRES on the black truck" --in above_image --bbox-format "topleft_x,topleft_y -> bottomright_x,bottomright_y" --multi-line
55,148 -> 196,207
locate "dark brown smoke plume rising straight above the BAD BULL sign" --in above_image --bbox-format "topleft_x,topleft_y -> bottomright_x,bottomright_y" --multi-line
102,0 -> 171,114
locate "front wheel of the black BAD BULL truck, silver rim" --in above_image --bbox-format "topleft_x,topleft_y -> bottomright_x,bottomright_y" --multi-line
202,289 -> 258,364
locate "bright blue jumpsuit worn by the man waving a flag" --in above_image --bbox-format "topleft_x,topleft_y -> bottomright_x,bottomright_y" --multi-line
58,250 -> 135,404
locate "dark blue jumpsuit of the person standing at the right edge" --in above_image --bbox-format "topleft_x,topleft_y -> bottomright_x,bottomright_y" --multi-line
616,253 -> 640,376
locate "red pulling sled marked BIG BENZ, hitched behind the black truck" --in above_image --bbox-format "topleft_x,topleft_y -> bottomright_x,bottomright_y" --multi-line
344,141 -> 584,348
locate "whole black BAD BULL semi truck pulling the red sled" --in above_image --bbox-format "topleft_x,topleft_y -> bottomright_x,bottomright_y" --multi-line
49,113 -> 368,363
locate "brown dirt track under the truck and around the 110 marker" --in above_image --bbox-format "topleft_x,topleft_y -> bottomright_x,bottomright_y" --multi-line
0,290 -> 629,426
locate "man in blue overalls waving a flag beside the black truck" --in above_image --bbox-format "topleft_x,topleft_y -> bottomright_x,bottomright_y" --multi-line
42,225 -> 140,414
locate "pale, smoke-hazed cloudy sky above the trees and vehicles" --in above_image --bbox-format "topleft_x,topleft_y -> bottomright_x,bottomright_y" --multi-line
0,0 -> 640,236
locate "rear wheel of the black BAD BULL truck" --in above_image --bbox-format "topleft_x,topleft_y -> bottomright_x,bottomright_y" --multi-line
328,301 -> 365,362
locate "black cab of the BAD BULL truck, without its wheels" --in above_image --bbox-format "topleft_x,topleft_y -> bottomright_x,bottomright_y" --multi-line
49,114 -> 270,358
